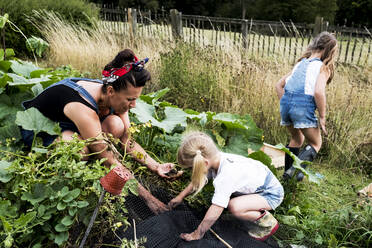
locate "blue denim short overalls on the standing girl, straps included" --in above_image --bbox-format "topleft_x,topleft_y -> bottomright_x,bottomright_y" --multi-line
280,58 -> 320,128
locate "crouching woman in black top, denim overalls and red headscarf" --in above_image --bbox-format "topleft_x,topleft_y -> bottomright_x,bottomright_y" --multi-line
21,49 -> 174,213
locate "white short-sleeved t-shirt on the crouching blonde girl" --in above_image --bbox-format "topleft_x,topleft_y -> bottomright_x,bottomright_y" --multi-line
209,152 -> 277,208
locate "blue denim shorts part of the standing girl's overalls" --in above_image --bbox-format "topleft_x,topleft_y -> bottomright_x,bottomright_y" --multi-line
280,92 -> 318,128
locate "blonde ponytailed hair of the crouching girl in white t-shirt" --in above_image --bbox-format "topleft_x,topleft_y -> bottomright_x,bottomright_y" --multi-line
177,132 -> 219,195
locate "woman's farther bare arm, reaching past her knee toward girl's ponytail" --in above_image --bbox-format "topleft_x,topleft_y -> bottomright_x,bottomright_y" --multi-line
119,112 -> 182,178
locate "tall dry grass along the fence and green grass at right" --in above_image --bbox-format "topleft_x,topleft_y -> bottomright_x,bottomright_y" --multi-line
33,11 -> 372,247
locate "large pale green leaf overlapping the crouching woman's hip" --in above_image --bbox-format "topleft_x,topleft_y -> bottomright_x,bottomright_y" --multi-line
16,108 -> 58,135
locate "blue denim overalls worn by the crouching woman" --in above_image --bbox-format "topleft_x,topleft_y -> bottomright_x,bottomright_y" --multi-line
21,78 -> 103,147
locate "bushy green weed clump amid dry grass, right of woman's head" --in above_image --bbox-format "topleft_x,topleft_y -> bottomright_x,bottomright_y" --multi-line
159,44 -> 217,111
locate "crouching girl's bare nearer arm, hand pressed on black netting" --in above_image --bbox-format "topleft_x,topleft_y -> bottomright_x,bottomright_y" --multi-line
180,204 -> 224,241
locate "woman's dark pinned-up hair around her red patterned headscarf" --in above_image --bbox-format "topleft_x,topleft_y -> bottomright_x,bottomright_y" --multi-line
102,49 -> 151,93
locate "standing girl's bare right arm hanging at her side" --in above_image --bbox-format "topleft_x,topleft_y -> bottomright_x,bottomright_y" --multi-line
314,69 -> 329,135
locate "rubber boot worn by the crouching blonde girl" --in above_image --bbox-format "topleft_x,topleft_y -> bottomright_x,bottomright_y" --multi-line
248,210 -> 279,241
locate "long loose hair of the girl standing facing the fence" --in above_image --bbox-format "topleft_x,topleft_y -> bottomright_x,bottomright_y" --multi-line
298,32 -> 338,84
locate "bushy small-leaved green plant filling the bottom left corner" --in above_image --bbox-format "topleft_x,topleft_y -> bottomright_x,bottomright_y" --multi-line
0,140 -> 105,245
